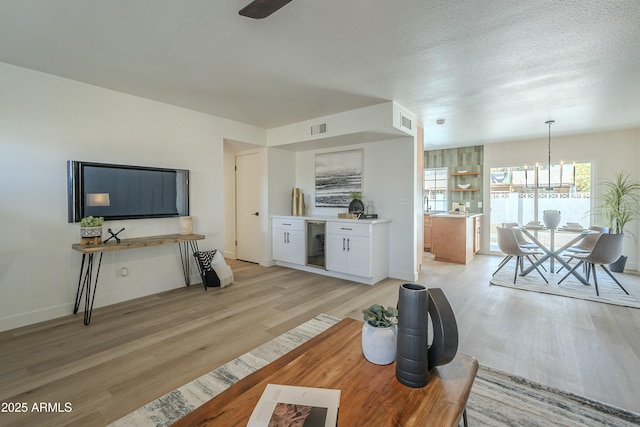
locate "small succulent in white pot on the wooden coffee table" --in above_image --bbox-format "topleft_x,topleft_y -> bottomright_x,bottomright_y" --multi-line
362,304 -> 398,365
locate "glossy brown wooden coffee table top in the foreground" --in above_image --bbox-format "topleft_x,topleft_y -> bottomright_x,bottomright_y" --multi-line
173,319 -> 478,427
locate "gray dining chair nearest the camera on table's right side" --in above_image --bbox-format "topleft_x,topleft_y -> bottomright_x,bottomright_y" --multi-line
558,233 -> 629,296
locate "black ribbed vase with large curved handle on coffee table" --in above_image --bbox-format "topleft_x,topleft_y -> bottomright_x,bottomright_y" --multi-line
396,283 -> 458,388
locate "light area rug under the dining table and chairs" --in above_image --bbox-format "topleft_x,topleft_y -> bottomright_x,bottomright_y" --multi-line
489,262 -> 640,308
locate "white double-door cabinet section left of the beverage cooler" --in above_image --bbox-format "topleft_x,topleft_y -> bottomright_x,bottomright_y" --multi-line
272,218 -> 306,265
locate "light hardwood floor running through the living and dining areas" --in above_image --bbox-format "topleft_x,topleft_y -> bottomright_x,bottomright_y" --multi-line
0,255 -> 640,426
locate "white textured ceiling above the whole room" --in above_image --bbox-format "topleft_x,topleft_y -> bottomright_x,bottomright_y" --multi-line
0,0 -> 640,148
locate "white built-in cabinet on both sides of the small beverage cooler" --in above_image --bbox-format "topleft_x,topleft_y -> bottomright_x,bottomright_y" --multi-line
272,216 -> 391,285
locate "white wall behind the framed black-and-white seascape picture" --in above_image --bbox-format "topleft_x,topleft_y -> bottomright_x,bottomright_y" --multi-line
295,137 -> 419,281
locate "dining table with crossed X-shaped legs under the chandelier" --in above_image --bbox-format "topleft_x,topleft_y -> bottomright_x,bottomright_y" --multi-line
519,226 -> 598,286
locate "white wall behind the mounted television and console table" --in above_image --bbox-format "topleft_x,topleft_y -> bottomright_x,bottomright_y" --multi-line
0,63 -> 266,330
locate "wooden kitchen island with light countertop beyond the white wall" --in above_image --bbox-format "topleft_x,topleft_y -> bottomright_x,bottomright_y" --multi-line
431,214 -> 482,264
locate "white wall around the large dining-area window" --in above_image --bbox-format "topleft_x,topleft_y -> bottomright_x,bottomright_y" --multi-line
483,128 -> 640,270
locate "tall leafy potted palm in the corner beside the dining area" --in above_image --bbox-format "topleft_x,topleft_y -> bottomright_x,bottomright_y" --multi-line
600,172 -> 640,272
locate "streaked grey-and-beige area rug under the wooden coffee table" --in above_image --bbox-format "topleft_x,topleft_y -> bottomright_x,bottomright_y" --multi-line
110,314 -> 640,427
